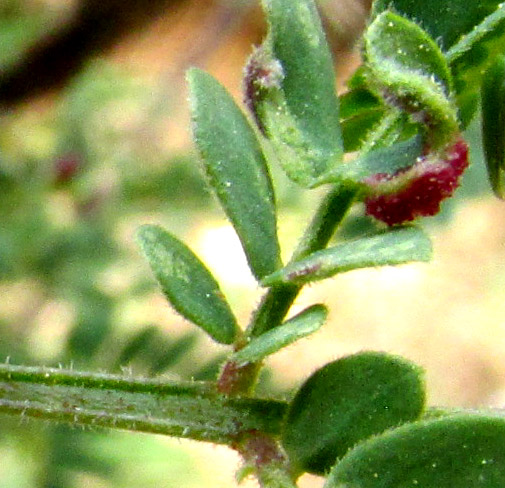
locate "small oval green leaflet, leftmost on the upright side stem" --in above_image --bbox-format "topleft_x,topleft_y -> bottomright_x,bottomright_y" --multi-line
137,225 -> 239,344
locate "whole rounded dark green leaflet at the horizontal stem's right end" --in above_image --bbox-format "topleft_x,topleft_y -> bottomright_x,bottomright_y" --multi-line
282,352 -> 425,474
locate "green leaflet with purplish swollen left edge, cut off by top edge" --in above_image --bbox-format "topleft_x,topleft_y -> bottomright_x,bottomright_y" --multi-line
244,0 -> 343,186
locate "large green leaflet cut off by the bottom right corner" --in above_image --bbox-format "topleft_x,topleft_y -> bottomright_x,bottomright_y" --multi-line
324,414 -> 505,488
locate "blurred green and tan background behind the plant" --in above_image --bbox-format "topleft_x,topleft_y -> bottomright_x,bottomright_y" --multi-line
0,0 -> 505,488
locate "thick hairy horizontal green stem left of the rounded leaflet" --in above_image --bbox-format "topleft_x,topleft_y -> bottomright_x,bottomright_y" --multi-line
0,364 -> 286,445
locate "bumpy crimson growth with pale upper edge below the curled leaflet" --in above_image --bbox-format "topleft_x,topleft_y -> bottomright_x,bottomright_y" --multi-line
365,138 -> 468,225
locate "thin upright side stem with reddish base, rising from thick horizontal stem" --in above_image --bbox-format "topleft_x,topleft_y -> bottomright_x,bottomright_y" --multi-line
218,185 -> 358,395
